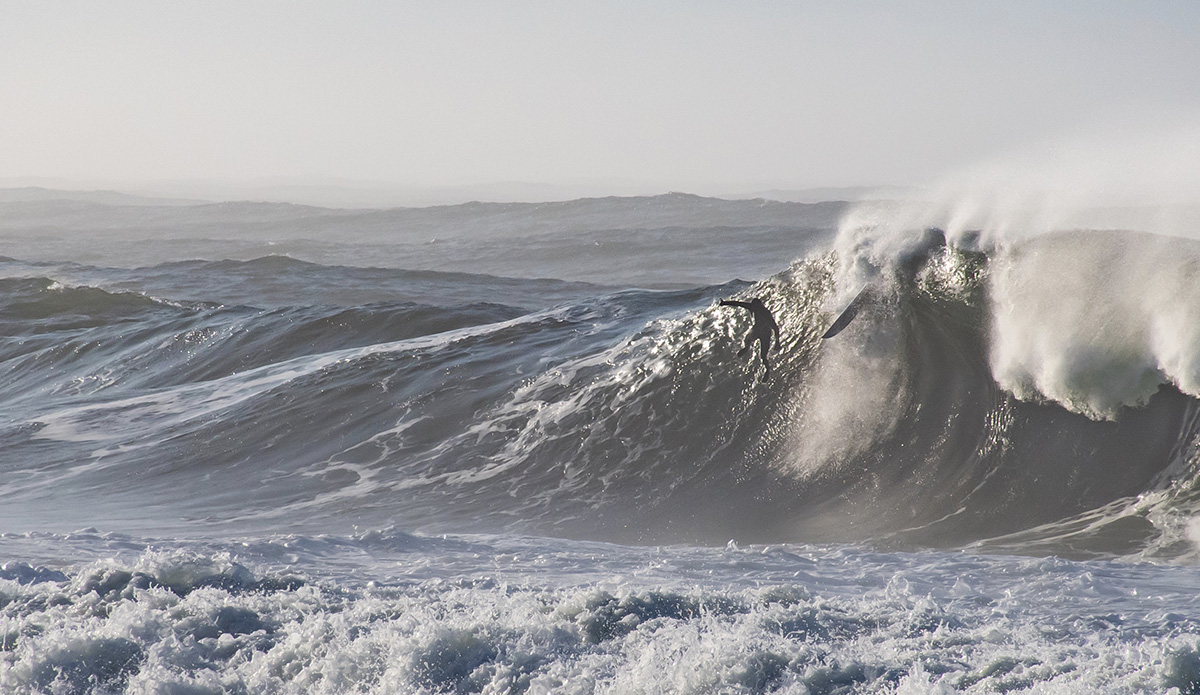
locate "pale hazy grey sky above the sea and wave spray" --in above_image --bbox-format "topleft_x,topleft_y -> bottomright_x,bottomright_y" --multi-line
0,0 -> 1200,192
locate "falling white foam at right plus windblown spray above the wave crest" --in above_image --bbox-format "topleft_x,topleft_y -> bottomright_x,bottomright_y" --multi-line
836,120 -> 1200,418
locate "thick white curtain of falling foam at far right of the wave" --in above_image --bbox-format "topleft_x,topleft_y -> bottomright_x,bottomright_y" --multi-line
990,233 -> 1200,418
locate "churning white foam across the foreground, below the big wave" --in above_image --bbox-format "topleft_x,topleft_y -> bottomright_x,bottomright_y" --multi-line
0,533 -> 1200,695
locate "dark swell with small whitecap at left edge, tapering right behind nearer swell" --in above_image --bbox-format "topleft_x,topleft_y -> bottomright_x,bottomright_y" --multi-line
0,277 -> 528,401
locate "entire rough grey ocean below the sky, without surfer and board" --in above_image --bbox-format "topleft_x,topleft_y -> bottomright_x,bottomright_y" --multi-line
0,191 -> 1200,695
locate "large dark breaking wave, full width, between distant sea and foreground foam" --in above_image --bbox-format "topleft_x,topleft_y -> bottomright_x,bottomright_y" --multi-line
0,220 -> 1200,558
